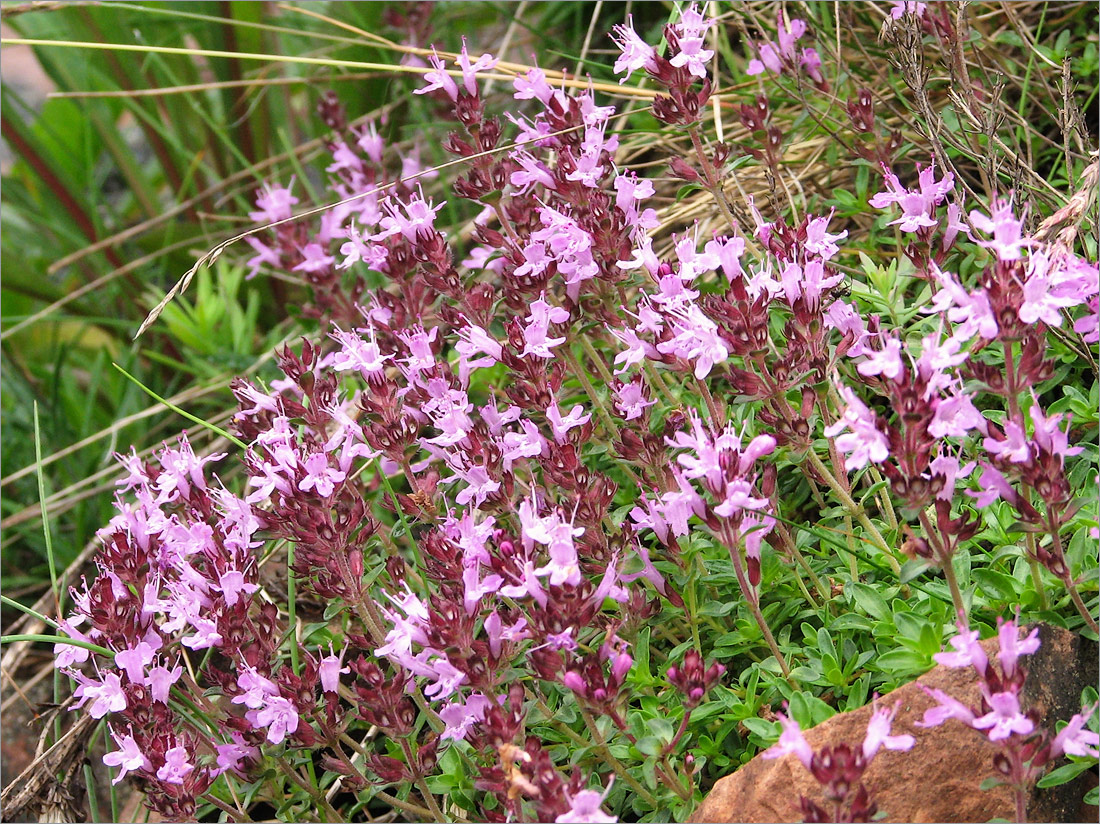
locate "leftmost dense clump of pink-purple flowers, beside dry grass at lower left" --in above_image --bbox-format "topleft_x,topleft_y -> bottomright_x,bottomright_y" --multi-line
55,437 -> 266,818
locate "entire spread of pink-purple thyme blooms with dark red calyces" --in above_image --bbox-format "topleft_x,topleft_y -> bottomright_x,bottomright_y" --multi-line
51,3 -> 1098,822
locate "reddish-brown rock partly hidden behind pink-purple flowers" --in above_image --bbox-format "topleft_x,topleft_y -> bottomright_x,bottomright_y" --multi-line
691,626 -> 1097,822
